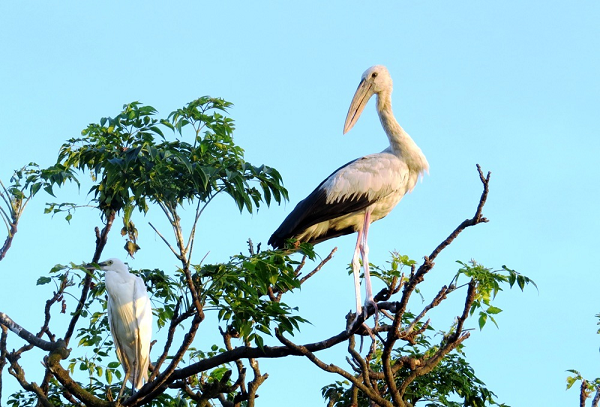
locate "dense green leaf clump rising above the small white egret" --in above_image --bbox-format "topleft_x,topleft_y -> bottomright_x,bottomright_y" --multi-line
54,96 -> 287,221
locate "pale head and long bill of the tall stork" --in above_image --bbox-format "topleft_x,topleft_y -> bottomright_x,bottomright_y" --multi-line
344,65 -> 393,134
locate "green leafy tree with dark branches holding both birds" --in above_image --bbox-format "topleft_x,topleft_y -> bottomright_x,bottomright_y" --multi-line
0,97 -> 532,407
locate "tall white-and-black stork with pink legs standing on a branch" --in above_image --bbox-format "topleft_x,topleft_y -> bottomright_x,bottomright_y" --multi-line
269,65 -> 429,321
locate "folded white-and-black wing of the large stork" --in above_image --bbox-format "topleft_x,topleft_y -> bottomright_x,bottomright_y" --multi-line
269,152 -> 406,248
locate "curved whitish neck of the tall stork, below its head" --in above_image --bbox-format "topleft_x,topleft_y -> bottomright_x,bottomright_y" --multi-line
377,92 -> 429,174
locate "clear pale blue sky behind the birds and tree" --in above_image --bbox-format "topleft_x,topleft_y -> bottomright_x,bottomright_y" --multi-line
0,1 -> 600,406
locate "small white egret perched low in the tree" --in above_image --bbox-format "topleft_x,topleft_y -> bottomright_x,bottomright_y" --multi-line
99,259 -> 152,397
